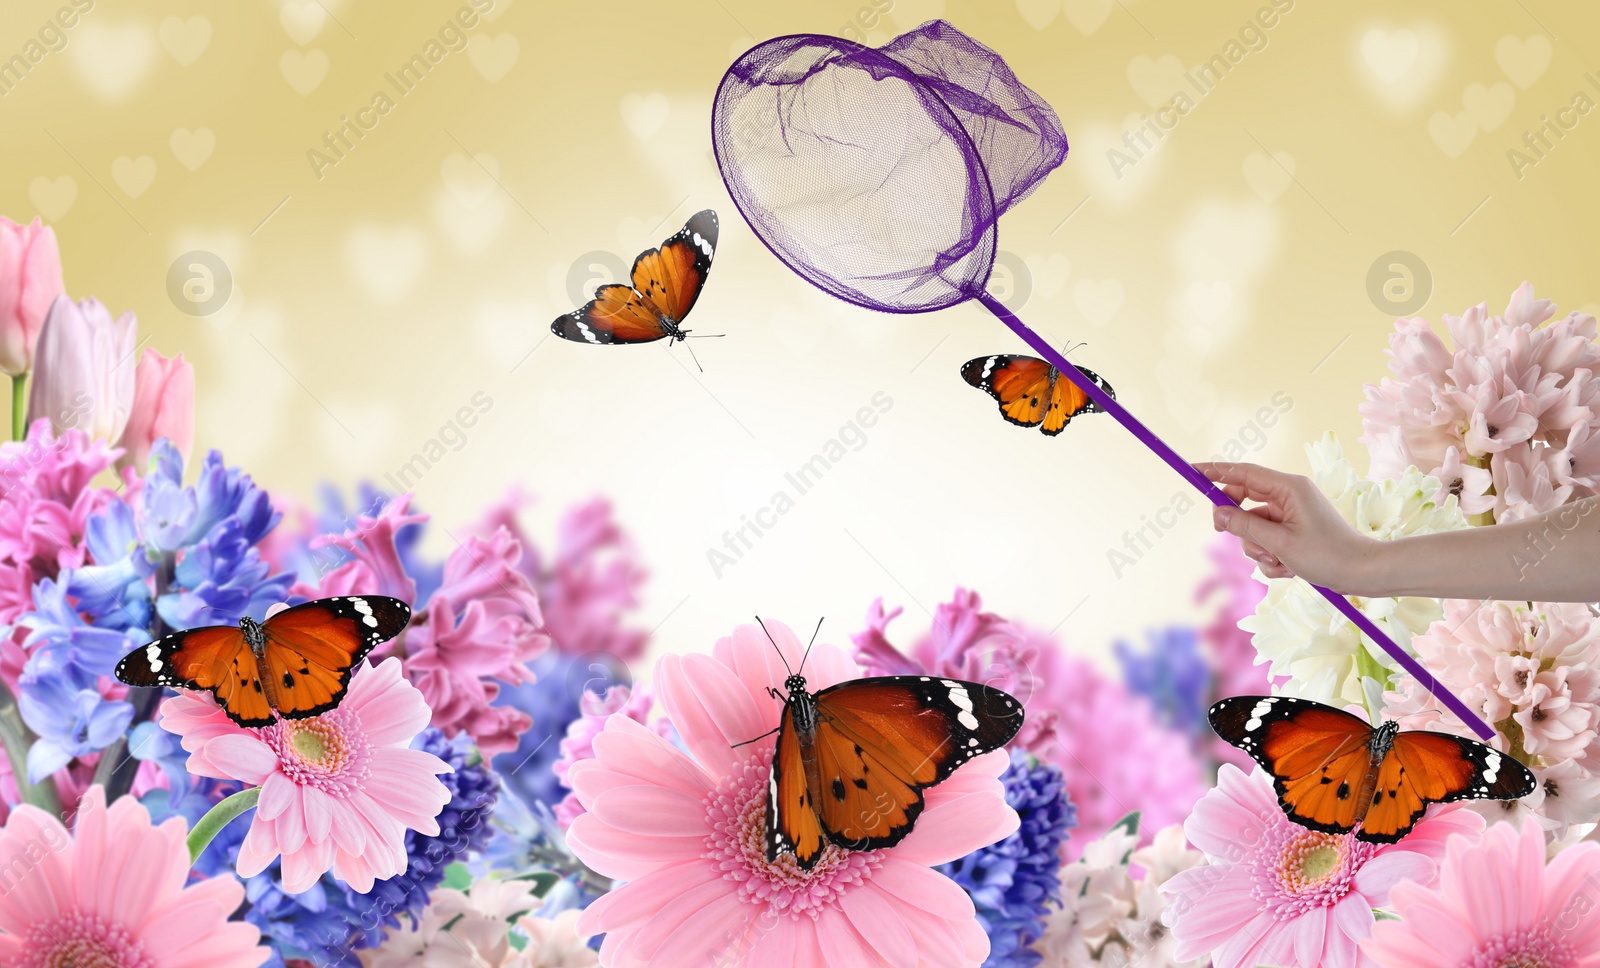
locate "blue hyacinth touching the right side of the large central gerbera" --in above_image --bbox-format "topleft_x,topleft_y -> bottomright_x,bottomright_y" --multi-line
939,750 -> 1077,968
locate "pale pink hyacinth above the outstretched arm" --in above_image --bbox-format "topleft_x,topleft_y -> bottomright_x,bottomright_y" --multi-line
1362,283 -> 1600,522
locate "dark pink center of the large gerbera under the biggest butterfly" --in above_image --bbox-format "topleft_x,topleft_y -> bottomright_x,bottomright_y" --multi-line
706,752 -> 882,918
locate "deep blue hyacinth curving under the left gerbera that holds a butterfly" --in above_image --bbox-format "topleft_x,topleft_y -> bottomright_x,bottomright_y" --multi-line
238,726 -> 499,968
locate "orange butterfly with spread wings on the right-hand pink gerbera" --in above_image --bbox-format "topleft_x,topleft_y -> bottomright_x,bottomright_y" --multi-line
1210,696 -> 1534,843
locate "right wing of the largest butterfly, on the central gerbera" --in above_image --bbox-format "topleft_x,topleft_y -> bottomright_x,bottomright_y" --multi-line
813,675 -> 1022,850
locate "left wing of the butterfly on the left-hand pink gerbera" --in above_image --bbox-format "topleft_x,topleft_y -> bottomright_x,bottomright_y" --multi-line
115,626 -> 274,726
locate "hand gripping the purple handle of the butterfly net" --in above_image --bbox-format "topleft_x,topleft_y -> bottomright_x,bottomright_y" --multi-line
1195,462 -> 1381,594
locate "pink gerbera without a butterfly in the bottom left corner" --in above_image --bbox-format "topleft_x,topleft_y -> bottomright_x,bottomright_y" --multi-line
0,786 -> 270,968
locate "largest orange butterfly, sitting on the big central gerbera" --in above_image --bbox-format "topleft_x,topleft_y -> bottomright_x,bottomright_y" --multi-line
748,624 -> 1022,870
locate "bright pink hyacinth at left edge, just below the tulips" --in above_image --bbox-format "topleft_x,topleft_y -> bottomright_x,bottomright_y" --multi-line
0,421 -> 120,617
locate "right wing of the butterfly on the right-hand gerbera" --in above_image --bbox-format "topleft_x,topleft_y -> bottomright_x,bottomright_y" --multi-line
1355,730 -> 1534,843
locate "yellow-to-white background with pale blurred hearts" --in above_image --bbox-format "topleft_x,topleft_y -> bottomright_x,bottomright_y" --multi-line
0,0 -> 1600,653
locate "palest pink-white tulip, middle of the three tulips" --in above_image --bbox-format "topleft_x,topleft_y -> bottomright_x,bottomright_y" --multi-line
27,294 -> 139,440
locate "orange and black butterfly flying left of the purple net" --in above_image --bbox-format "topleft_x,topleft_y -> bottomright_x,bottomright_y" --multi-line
550,208 -> 717,346
